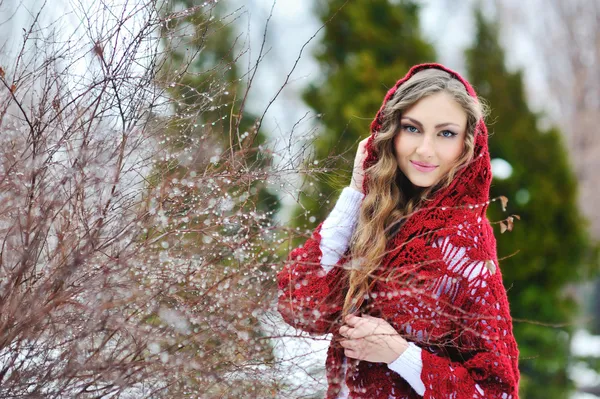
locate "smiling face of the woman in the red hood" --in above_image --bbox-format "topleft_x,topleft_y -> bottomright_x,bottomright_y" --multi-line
394,91 -> 467,188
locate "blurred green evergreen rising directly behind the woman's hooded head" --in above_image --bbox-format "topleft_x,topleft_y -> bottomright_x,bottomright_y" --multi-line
293,0 -> 435,238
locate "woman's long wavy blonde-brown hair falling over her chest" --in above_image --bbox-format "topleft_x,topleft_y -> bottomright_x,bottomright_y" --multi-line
343,68 -> 487,315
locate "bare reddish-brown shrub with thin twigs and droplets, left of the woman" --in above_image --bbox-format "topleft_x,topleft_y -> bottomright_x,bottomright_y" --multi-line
0,0 -> 318,398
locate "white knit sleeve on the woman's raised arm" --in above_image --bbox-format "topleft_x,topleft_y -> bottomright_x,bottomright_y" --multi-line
319,187 -> 365,272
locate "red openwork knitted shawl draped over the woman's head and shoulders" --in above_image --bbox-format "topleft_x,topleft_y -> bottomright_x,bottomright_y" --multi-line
278,64 -> 519,399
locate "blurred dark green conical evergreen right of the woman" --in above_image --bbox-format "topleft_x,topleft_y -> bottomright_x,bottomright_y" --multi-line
466,11 -> 589,399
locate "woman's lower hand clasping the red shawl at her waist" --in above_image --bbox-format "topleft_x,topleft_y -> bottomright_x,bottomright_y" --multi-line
339,315 -> 408,364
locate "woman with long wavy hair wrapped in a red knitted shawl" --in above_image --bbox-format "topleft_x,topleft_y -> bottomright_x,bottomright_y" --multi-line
278,64 -> 519,399
